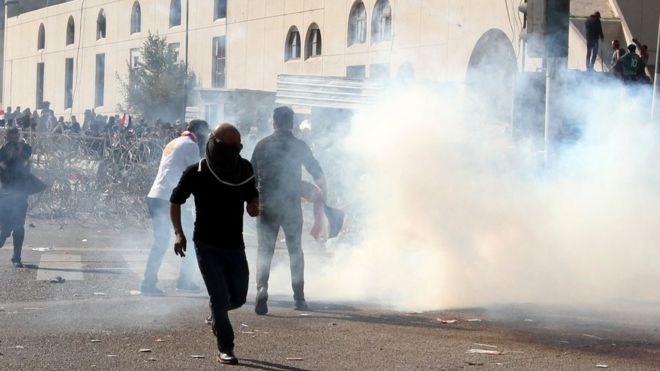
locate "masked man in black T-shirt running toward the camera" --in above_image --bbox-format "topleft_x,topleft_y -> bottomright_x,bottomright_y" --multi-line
170,124 -> 259,364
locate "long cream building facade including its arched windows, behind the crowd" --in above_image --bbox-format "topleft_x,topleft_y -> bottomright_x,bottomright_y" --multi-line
2,0 -> 652,126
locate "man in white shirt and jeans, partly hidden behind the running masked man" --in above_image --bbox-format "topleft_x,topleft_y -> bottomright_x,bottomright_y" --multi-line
140,120 -> 209,296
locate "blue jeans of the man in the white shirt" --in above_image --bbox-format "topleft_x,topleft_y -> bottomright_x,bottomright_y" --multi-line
142,197 -> 195,287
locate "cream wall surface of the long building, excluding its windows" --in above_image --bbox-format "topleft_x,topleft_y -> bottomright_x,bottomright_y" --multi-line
3,0 -> 521,117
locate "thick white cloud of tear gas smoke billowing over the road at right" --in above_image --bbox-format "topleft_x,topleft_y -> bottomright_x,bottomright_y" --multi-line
284,80 -> 660,310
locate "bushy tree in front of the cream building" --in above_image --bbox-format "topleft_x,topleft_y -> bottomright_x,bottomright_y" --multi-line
118,33 -> 196,122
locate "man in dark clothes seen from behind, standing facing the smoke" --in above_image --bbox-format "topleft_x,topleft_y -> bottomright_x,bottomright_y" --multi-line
252,107 -> 327,315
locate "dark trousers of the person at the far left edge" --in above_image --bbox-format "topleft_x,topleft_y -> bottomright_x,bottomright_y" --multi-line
0,193 -> 27,263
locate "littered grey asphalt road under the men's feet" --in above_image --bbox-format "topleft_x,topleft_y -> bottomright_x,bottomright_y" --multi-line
0,221 -> 660,370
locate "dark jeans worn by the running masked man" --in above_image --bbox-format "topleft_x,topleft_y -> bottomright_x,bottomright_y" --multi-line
195,241 -> 250,352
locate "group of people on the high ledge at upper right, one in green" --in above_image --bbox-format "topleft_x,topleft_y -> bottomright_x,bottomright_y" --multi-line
585,12 -> 651,83
